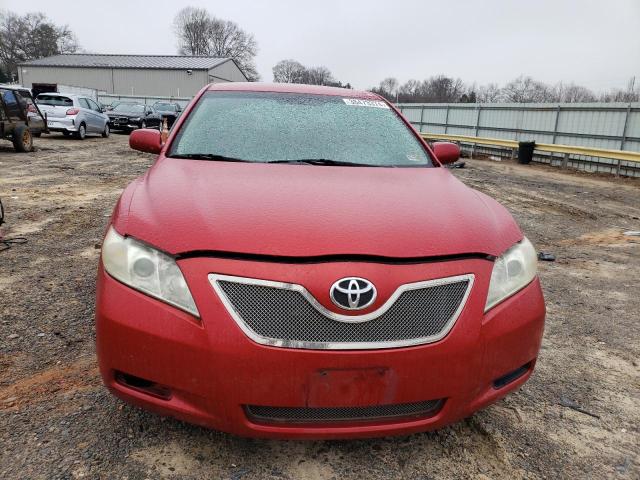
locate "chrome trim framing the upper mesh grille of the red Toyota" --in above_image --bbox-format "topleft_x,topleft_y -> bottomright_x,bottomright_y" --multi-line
208,273 -> 475,350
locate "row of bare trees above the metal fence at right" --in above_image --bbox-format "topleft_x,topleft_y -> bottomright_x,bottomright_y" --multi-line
370,75 -> 640,103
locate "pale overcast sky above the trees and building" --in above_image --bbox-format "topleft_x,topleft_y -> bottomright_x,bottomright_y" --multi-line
7,0 -> 640,90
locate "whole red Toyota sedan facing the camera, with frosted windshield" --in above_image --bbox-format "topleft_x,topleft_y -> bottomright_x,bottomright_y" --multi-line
96,83 -> 545,438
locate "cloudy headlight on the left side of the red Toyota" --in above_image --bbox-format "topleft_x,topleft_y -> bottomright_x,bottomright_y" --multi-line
102,227 -> 200,317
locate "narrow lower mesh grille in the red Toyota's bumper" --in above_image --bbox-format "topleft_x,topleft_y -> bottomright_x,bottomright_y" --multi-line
245,400 -> 444,423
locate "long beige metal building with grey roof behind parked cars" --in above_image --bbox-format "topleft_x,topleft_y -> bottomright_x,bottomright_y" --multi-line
18,53 -> 247,97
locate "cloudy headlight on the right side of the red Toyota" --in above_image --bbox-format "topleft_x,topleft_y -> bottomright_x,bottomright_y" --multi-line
484,237 -> 538,312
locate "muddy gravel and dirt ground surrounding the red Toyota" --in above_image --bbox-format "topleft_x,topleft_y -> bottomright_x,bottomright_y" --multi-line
0,134 -> 640,480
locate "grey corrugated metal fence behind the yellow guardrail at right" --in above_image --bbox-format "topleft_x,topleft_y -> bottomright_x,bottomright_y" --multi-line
398,103 -> 640,175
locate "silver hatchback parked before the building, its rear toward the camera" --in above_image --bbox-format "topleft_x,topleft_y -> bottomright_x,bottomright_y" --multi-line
36,93 -> 110,140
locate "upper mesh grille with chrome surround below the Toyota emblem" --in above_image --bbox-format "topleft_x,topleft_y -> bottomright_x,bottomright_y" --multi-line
210,275 -> 473,349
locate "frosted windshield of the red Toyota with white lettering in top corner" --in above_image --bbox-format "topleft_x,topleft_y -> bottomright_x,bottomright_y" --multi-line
169,92 -> 432,167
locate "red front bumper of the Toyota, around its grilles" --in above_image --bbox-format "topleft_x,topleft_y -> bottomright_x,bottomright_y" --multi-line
96,258 -> 545,438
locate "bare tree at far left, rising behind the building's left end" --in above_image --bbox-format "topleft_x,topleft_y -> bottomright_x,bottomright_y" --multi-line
0,11 -> 78,77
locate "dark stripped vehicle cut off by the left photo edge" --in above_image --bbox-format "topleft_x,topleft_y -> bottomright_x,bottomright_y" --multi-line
0,85 -> 46,152
